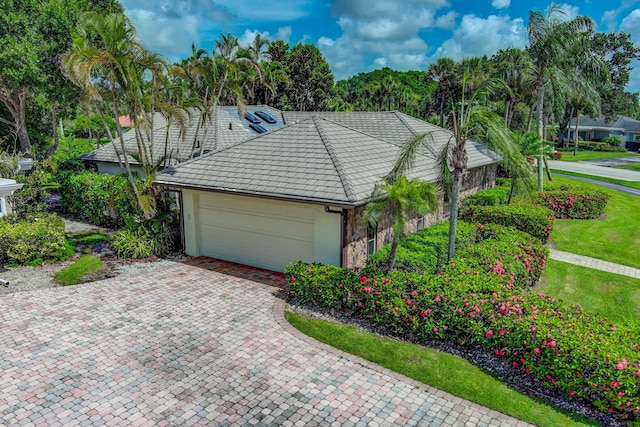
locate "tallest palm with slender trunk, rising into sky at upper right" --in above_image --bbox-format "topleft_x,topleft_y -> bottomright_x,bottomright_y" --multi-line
527,3 -> 595,191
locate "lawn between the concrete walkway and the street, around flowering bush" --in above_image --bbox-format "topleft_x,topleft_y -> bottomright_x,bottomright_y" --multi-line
551,177 -> 640,268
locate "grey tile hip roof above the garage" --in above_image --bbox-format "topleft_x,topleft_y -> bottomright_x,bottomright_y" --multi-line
156,112 -> 498,206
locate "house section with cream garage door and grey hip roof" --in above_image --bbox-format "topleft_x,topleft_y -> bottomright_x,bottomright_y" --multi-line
155,112 -> 499,271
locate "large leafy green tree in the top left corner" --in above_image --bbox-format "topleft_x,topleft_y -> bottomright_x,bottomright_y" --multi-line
0,0 -> 121,155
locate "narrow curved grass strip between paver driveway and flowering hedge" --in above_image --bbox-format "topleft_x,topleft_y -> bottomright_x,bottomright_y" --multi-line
286,313 -> 597,427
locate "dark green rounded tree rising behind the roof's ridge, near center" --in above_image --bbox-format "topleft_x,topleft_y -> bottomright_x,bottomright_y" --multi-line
277,43 -> 333,111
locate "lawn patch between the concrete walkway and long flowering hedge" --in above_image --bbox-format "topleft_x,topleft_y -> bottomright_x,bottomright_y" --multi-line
535,260 -> 640,323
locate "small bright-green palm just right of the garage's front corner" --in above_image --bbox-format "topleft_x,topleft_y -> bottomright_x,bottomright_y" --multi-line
364,175 -> 438,273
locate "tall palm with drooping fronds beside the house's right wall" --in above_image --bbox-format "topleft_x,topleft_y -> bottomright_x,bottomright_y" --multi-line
389,74 -> 531,261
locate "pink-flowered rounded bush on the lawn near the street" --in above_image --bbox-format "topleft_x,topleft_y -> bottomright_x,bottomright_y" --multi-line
537,185 -> 608,219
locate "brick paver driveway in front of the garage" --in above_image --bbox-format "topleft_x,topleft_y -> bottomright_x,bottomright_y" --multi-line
0,259 -> 525,426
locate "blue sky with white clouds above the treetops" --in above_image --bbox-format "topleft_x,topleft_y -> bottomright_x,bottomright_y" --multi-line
122,0 -> 640,91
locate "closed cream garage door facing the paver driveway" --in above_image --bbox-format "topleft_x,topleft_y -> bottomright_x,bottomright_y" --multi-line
197,194 -> 328,271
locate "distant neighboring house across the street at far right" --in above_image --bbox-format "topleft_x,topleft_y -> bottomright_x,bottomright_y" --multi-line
567,116 -> 640,147
